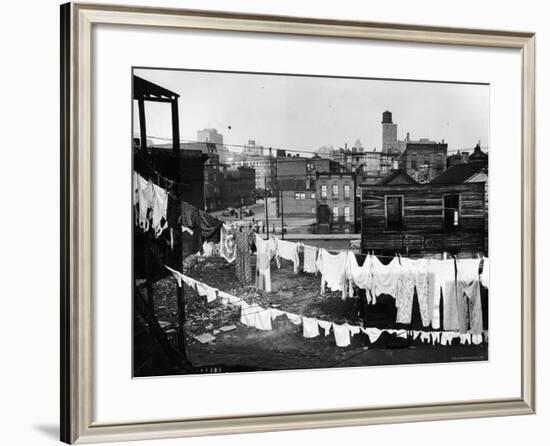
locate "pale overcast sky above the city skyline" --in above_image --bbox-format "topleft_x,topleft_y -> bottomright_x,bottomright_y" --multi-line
134,69 -> 489,155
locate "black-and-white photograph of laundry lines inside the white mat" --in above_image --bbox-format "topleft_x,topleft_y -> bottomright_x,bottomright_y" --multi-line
133,67 -> 491,378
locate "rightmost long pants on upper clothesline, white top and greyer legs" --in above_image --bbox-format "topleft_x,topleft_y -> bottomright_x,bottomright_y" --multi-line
456,259 -> 483,335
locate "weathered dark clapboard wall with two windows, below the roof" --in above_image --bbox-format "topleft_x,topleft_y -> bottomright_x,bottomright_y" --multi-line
361,183 -> 487,257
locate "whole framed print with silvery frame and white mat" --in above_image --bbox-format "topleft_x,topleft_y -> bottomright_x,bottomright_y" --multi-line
61,3 -> 535,443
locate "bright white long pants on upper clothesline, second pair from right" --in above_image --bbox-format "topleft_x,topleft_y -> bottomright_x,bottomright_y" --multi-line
428,259 -> 459,330
